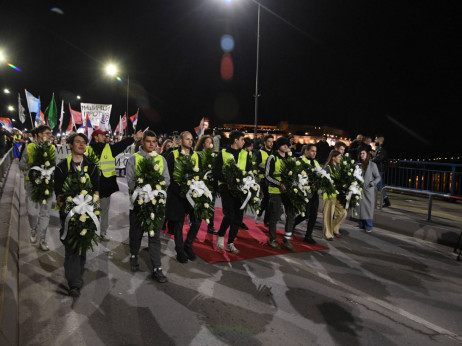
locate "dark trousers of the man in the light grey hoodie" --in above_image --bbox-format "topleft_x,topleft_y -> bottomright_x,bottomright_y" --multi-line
129,210 -> 163,269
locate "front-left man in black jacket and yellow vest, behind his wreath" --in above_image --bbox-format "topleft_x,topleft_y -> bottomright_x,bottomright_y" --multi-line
54,133 -> 99,297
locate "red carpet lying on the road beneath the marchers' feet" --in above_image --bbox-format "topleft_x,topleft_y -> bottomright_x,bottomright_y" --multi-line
163,208 -> 327,263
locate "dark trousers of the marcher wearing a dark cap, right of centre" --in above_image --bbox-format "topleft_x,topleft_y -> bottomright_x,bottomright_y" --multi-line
268,193 -> 295,241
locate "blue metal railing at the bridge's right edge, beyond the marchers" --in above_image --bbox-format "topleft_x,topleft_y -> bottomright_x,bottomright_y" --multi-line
384,160 -> 462,197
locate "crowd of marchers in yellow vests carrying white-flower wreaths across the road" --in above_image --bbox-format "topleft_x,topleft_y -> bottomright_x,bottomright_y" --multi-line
19,125 -> 390,297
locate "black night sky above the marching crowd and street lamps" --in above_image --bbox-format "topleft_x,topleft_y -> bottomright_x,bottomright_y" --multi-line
0,0 -> 462,157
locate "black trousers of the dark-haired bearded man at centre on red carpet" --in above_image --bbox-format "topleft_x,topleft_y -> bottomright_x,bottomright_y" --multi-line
218,188 -> 244,244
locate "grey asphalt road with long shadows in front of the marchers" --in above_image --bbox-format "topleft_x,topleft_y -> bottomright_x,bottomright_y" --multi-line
12,174 -> 462,345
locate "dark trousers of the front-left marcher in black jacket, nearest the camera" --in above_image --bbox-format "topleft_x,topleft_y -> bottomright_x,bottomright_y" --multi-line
59,218 -> 87,289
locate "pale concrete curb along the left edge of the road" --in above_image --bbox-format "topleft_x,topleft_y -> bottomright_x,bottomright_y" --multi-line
0,162 -> 21,345
